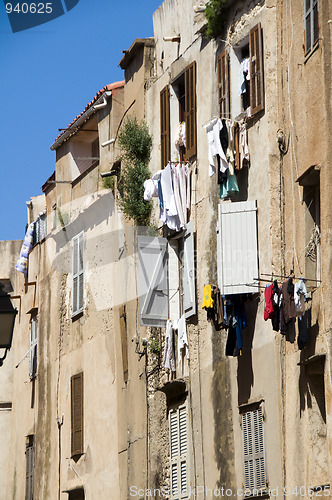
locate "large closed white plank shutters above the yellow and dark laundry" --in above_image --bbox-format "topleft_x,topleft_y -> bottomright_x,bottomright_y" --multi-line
217,200 -> 258,295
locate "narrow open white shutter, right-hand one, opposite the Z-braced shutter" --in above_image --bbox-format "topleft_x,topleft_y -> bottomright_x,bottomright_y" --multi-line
182,221 -> 196,318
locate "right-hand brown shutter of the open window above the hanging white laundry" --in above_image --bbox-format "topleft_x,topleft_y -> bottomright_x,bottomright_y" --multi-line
184,62 -> 197,158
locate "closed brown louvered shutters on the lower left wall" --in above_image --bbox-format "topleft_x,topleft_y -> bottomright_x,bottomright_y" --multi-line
71,372 -> 83,456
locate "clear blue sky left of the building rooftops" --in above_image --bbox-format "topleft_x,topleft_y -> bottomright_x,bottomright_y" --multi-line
0,0 -> 162,240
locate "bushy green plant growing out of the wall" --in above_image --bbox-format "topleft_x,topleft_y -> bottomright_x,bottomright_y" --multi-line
118,117 -> 152,226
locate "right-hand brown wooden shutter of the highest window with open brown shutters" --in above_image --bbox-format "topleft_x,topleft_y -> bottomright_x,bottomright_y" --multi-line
249,23 -> 264,115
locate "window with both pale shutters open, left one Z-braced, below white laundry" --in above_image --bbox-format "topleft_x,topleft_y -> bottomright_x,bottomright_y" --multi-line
138,222 -> 196,326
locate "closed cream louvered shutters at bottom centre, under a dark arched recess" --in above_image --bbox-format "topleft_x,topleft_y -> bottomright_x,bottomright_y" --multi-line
169,404 -> 189,500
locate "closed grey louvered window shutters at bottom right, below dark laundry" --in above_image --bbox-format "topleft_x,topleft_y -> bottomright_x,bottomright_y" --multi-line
241,408 -> 266,496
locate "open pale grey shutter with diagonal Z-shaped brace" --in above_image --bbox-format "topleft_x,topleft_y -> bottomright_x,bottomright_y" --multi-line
138,236 -> 168,326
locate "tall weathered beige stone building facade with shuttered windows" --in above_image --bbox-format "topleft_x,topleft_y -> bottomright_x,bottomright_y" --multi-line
1,0 -> 332,500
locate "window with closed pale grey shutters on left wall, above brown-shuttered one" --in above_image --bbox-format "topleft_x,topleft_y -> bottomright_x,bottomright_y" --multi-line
72,231 -> 84,316
